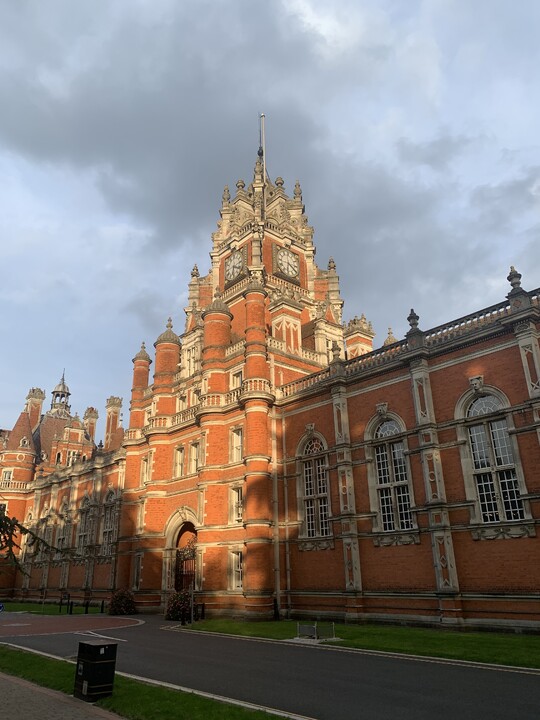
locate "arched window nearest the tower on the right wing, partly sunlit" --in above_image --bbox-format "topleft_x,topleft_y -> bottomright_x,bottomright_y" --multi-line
301,437 -> 332,538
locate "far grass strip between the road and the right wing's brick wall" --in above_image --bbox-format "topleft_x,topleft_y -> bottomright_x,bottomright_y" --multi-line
192,619 -> 540,668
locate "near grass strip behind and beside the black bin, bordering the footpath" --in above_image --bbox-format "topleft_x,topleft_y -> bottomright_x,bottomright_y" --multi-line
0,645 -> 271,720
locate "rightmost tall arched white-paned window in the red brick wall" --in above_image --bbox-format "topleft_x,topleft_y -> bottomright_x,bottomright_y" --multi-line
467,395 -> 525,523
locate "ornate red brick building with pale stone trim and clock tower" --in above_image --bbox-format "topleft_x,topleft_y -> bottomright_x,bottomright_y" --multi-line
0,156 -> 540,627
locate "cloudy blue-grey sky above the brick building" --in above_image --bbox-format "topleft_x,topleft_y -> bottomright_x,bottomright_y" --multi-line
0,0 -> 540,437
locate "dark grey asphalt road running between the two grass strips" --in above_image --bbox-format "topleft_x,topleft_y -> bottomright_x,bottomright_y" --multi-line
2,617 -> 540,720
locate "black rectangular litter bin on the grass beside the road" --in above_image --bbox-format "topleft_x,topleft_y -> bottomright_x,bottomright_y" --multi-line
73,640 -> 118,702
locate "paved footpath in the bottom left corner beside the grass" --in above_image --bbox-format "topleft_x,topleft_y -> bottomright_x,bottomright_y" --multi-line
0,673 -> 120,720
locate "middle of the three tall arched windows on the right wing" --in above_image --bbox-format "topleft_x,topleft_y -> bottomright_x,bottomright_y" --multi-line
374,419 -> 414,532
